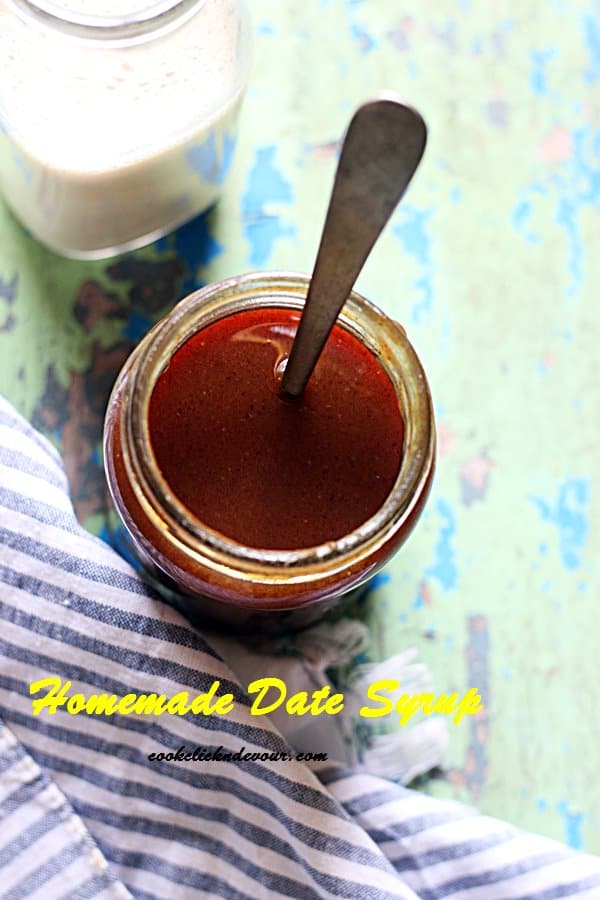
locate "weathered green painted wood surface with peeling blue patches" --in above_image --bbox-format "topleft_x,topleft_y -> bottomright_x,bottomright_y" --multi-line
0,0 -> 600,852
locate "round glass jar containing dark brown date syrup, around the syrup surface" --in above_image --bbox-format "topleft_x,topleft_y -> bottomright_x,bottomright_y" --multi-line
104,273 -> 435,632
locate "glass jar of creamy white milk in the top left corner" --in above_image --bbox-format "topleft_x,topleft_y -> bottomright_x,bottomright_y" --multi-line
0,0 -> 250,259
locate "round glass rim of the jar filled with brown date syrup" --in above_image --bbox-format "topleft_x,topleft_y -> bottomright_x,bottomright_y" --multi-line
121,272 -> 435,581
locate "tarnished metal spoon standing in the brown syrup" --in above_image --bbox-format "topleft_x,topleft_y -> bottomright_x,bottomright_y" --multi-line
281,95 -> 427,397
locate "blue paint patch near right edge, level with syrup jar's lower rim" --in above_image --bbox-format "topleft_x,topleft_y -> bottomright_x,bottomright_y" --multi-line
530,478 -> 590,570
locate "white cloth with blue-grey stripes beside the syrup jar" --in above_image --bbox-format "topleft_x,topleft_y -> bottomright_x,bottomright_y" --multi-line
0,401 -> 600,900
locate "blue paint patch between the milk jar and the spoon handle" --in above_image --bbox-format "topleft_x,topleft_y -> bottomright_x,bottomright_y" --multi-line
242,146 -> 296,266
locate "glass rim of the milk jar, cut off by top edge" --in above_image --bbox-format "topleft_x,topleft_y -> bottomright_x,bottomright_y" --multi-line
5,0 -> 206,43
